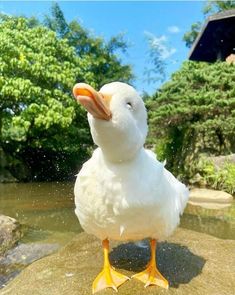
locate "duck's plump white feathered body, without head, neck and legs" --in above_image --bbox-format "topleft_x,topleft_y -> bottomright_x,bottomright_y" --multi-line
75,148 -> 188,241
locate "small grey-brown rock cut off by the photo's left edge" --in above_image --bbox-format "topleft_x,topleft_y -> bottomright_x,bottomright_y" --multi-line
0,214 -> 23,257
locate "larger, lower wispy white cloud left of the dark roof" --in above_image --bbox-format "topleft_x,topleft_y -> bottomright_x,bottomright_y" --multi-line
144,31 -> 177,60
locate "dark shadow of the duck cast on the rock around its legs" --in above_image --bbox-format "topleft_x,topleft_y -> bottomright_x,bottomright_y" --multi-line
110,242 -> 206,288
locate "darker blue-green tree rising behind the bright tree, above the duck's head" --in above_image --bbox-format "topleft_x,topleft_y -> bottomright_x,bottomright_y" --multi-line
44,3 -> 133,86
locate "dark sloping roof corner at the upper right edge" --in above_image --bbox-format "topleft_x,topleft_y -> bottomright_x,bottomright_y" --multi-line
189,9 -> 235,62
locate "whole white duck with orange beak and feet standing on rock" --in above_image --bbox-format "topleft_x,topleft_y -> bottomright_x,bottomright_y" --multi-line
73,82 -> 188,293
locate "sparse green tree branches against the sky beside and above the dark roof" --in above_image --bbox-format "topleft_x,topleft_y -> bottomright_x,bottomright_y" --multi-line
183,0 -> 235,48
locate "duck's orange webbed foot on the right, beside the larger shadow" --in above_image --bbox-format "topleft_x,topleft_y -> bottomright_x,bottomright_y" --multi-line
132,264 -> 169,289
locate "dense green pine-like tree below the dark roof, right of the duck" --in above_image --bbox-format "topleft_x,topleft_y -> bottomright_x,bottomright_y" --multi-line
148,62 -> 235,183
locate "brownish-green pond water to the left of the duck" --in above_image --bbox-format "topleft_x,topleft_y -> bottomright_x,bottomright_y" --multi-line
0,182 -> 81,244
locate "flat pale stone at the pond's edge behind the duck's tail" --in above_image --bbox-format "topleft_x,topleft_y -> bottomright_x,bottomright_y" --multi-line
189,188 -> 233,210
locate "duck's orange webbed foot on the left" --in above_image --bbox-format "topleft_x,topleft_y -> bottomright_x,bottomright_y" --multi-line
92,266 -> 130,294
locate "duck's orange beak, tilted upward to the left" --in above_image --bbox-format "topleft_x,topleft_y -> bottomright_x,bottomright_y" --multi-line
73,83 -> 112,121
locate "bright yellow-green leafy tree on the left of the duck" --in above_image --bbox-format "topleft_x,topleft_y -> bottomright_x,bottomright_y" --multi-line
0,18 -> 92,182
